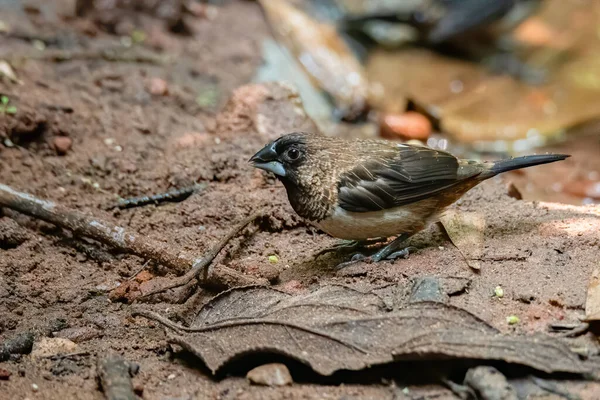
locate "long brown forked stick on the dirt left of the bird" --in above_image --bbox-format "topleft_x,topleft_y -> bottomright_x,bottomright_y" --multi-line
0,184 -> 258,287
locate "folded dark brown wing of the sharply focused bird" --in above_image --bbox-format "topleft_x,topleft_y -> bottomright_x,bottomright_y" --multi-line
338,145 -> 474,212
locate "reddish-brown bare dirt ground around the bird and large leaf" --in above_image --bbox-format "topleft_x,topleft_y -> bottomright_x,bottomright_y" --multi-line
0,0 -> 600,400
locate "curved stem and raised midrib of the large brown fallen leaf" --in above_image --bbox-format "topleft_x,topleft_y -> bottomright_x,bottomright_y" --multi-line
131,310 -> 368,354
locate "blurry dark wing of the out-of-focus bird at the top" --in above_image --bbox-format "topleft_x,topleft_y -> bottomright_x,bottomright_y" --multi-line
428,0 -> 515,43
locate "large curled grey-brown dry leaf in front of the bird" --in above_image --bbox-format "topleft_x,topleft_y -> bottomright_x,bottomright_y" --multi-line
137,286 -> 588,375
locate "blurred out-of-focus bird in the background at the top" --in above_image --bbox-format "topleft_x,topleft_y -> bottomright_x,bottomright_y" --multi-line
325,0 -> 545,83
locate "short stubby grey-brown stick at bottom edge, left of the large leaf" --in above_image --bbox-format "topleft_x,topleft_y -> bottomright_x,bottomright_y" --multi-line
98,355 -> 137,400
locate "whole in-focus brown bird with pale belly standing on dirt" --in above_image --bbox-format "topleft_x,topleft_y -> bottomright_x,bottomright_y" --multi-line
249,132 -> 570,264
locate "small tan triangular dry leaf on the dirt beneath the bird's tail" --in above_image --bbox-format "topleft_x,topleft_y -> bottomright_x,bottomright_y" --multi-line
440,210 -> 485,270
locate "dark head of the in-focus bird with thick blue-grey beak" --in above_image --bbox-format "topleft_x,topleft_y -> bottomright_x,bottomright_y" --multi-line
250,133 -> 310,183
